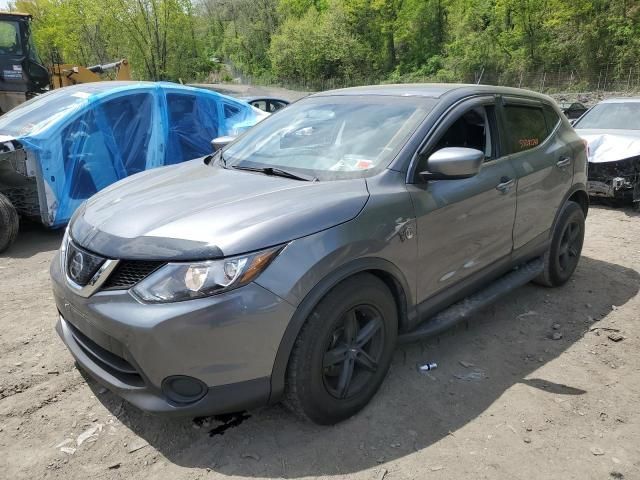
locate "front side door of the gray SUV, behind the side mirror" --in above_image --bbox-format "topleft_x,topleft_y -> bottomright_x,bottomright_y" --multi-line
408,97 -> 516,302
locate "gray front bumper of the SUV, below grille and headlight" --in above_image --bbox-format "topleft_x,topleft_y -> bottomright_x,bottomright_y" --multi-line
51,251 -> 295,416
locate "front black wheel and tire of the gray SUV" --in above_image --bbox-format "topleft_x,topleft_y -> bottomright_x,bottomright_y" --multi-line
284,273 -> 398,425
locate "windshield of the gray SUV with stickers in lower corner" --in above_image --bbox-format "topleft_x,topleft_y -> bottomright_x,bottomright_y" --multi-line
223,96 -> 436,180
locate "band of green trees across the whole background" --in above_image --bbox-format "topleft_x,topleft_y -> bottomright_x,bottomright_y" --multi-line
8,0 -> 640,88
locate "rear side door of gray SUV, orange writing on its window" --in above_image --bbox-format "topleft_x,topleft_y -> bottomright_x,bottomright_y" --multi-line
501,97 -> 573,249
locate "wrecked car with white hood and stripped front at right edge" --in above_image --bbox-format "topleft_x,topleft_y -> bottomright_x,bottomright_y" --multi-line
575,99 -> 640,205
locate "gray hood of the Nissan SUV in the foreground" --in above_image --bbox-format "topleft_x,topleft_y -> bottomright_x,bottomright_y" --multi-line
71,159 -> 369,260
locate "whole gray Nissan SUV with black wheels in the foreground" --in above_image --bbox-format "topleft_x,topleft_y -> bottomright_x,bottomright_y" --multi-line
51,85 -> 588,424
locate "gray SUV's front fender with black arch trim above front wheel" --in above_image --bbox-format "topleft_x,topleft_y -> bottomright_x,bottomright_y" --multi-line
256,171 -> 418,401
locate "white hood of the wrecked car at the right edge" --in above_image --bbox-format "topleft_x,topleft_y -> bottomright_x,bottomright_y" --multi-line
576,129 -> 640,163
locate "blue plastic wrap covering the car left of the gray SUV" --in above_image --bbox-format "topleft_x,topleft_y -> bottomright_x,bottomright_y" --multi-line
0,82 -> 263,227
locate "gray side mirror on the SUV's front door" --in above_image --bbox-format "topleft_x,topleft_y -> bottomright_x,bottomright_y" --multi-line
420,147 -> 484,180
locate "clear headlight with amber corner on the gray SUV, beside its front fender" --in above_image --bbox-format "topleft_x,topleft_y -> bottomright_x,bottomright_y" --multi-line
132,246 -> 283,303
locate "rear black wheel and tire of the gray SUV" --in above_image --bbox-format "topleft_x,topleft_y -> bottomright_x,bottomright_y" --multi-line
534,202 -> 584,287
